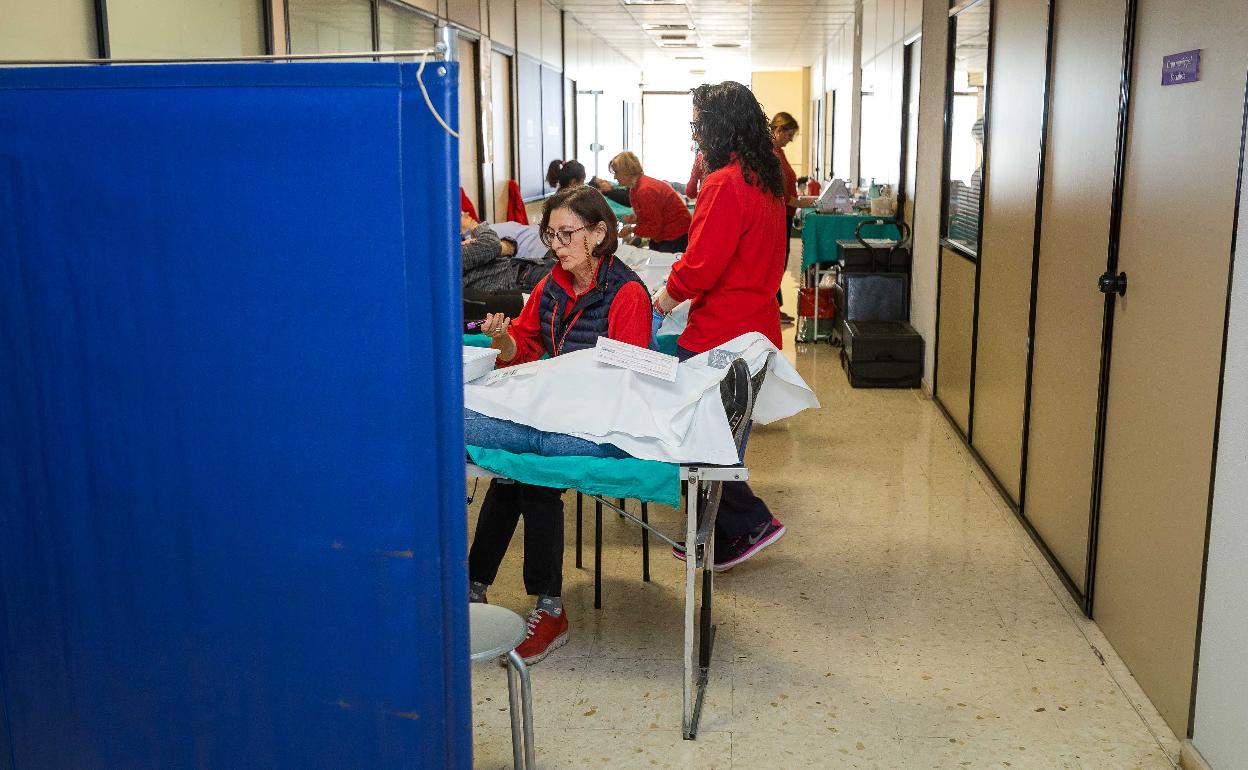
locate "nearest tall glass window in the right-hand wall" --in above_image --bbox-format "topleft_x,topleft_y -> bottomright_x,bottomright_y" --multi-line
941,0 -> 992,258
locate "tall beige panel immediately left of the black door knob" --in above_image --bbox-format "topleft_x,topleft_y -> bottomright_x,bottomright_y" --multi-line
1025,0 -> 1126,592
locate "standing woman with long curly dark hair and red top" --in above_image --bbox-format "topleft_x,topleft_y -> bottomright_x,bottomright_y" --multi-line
654,82 -> 789,572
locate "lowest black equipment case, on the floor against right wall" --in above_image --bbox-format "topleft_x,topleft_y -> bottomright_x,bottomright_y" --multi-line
841,321 -> 924,388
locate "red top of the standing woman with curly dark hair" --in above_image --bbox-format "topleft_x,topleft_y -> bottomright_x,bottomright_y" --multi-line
668,161 -> 787,353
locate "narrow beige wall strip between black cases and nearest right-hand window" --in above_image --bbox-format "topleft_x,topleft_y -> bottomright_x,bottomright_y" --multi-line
910,0 -> 948,392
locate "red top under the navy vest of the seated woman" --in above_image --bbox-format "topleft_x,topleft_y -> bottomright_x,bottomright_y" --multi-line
498,257 -> 650,368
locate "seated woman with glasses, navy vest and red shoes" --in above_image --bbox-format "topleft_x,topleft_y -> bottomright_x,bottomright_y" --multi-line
467,185 -> 650,663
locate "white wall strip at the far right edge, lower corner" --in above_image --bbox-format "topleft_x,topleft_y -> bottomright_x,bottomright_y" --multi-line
1192,135 -> 1248,770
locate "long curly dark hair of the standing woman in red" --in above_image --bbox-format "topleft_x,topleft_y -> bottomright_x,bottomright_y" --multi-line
693,80 -> 784,198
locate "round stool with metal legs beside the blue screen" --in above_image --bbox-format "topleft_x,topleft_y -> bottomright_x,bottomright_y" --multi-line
468,604 -> 537,770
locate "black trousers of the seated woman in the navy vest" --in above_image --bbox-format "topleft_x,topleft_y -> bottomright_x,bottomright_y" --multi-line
468,479 -> 563,597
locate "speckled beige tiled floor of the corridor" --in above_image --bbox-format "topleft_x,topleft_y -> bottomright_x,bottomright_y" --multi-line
469,263 -> 1178,770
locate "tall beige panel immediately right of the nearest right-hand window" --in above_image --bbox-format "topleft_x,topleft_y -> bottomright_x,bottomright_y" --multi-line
971,0 -> 1048,504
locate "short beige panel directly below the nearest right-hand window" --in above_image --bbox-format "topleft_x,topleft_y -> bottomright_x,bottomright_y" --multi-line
936,248 -> 975,433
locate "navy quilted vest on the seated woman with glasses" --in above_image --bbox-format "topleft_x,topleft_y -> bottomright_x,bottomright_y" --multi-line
538,256 -> 649,356
